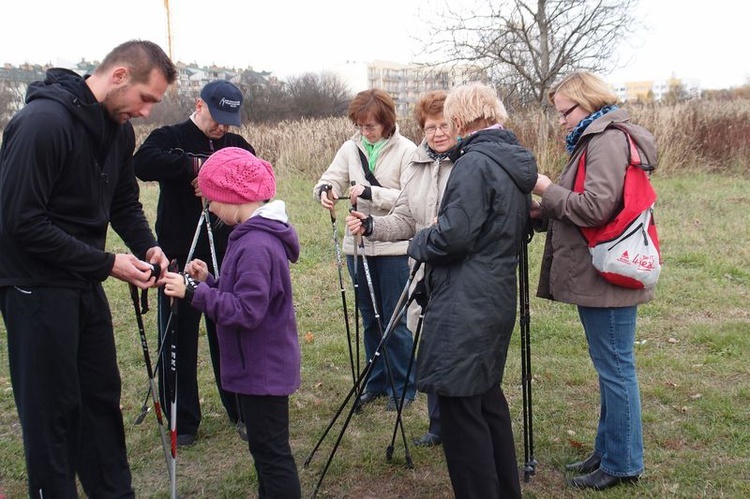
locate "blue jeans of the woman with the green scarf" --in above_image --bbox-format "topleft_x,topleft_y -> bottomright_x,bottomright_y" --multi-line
346,255 -> 417,400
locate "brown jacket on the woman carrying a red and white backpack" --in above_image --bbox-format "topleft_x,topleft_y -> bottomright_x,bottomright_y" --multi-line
537,108 -> 657,307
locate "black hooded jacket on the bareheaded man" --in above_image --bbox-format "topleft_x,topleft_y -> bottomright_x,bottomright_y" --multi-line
0,69 -> 156,287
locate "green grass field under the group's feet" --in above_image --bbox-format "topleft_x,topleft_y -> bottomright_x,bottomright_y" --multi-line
0,169 -> 750,499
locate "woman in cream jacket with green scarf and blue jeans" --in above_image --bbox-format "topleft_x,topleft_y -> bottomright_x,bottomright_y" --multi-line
313,89 -> 417,411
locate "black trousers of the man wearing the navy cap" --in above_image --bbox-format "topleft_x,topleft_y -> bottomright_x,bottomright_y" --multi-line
157,256 -> 239,435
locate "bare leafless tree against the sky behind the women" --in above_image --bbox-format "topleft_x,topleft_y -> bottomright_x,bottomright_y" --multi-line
425,0 -> 640,104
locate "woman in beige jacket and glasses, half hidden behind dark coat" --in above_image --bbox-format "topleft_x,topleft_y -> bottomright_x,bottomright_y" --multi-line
346,90 -> 456,447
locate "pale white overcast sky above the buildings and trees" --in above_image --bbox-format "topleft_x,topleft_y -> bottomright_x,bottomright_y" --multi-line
0,0 -> 750,88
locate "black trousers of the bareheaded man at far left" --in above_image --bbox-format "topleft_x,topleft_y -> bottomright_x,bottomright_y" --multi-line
0,283 -> 135,499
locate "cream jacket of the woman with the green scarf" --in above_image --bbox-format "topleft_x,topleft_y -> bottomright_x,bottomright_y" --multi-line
313,128 -> 417,256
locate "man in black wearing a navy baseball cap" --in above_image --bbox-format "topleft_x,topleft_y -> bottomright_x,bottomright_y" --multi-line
134,80 -> 255,446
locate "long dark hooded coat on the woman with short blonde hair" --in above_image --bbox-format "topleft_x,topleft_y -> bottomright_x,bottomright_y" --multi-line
409,129 -> 537,397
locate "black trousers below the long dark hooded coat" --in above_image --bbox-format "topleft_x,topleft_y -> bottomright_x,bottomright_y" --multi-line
438,387 -> 521,499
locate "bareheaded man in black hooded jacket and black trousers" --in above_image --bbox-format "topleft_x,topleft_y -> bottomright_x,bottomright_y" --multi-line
0,41 -> 177,498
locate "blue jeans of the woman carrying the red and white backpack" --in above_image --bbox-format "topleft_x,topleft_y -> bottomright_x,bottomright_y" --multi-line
578,306 -> 643,476
